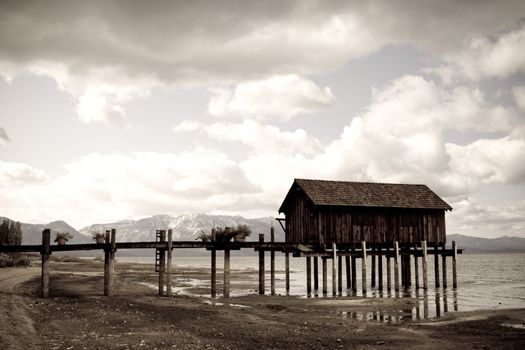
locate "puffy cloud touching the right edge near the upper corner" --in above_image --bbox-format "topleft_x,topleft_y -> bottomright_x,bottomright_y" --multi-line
429,25 -> 525,83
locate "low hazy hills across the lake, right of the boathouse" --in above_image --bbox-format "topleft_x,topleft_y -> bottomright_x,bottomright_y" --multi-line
447,234 -> 525,253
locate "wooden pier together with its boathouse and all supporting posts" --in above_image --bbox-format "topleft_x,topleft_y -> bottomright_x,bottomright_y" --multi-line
0,179 -> 462,298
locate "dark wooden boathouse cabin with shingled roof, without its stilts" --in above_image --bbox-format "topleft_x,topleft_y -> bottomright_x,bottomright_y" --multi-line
279,179 -> 452,246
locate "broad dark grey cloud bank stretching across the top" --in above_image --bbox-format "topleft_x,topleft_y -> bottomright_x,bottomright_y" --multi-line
0,0 -> 525,122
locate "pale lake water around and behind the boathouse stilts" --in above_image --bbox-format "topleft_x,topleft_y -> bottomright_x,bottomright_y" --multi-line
117,252 -> 525,322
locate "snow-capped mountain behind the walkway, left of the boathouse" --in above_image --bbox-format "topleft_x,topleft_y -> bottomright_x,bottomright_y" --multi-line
80,214 -> 284,242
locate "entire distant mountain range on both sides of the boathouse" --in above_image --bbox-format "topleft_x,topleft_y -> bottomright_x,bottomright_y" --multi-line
0,214 -> 525,253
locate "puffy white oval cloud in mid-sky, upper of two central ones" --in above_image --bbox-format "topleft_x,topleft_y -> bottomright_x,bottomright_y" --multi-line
208,75 -> 335,120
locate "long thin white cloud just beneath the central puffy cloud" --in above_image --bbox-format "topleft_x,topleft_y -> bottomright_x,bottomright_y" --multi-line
204,120 -> 322,155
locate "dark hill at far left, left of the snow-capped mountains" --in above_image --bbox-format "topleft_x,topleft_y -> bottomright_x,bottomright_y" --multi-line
0,217 -> 92,244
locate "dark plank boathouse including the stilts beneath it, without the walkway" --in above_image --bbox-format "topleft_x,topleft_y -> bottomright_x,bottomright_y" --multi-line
278,179 -> 457,294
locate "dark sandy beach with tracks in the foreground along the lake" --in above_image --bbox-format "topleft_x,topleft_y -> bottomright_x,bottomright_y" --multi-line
0,261 -> 525,349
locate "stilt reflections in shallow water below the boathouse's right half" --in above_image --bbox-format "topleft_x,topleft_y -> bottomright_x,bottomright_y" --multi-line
339,289 -> 458,323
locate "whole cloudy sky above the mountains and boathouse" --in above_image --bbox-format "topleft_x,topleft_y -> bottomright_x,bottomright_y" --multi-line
0,0 -> 525,238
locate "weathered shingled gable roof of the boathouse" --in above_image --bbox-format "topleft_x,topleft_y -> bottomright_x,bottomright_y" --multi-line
279,179 -> 452,213
